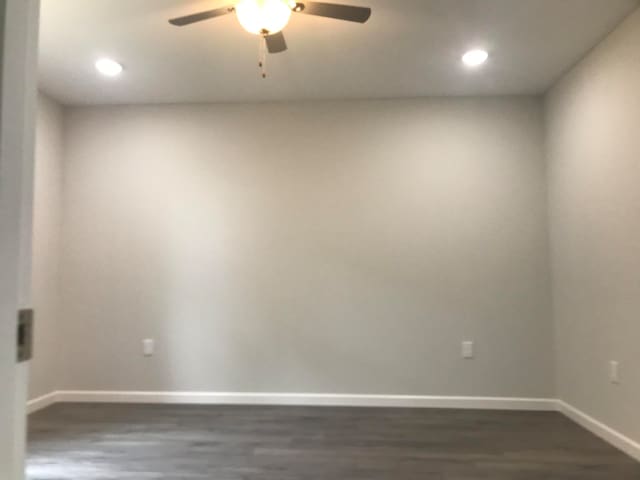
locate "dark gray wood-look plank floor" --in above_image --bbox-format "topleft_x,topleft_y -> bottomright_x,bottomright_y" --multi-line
28,404 -> 640,480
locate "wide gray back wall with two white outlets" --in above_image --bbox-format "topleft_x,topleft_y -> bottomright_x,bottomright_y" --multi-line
60,98 -> 554,397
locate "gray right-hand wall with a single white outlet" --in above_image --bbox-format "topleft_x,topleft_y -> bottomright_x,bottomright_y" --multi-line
546,11 -> 640,440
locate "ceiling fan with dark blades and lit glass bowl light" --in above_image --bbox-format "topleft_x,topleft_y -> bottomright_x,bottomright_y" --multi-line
169,0 -> 371,57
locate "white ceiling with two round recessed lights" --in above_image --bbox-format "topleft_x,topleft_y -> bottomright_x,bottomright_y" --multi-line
40,0 -> 638,104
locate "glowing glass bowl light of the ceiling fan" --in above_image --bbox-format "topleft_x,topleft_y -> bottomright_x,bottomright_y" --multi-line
235,0 -> 292,35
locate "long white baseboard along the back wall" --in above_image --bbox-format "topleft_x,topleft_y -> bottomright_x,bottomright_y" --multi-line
57,391 -> 556,411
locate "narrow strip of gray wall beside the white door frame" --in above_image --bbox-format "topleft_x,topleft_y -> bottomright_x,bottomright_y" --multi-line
29,94 -> 64,398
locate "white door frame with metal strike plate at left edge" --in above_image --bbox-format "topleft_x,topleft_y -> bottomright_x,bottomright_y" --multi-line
0,0 -> 39,480
